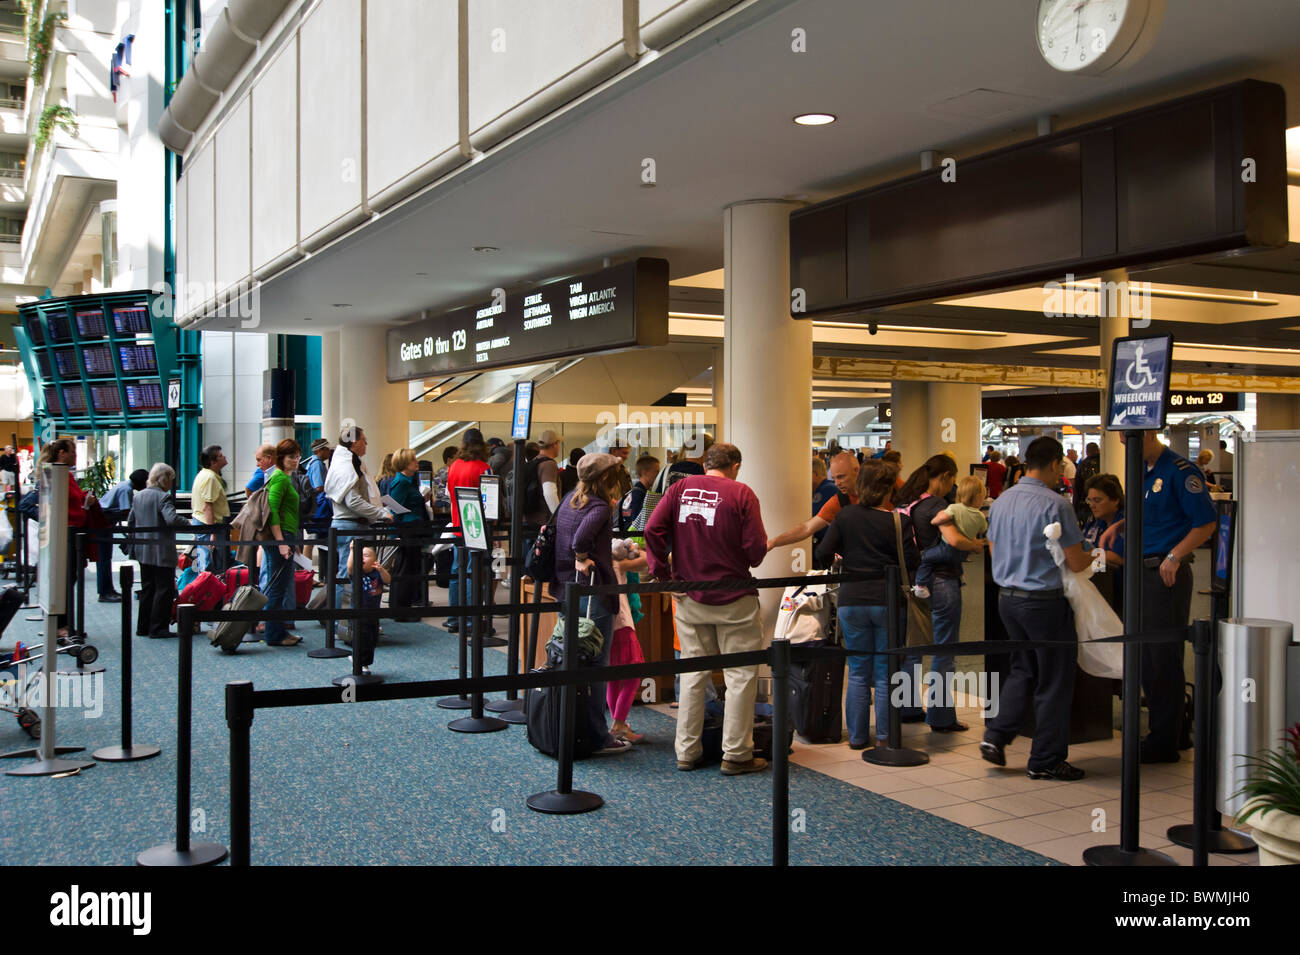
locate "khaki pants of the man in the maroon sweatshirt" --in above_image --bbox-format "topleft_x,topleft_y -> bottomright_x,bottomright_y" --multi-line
672,596 -> 763,763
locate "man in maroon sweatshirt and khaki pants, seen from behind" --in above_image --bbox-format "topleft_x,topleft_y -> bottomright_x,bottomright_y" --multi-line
646,443 -> 767,776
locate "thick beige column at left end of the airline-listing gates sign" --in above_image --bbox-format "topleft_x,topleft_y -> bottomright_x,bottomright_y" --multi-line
338,325 -> 411,462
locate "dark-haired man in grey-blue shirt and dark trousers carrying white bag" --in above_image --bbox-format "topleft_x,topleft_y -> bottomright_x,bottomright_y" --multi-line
979,437 -> 1092,782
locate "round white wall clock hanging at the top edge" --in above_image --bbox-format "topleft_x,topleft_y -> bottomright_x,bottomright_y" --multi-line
1037,0 -> 1147,73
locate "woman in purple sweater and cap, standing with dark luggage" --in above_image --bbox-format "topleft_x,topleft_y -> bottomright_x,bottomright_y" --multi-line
554,453 -> 632,756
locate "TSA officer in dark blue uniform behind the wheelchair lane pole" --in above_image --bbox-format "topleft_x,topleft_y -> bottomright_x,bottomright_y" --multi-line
1099,431 -> 1216,763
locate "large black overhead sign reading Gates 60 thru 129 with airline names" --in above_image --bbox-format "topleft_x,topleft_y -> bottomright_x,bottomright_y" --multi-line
387,259 -> 668,382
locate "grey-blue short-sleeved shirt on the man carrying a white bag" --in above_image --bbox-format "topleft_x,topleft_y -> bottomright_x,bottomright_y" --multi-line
988,476 -> 1083,590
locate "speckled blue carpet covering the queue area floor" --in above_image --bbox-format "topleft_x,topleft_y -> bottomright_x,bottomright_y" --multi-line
0,589 -> 1053,865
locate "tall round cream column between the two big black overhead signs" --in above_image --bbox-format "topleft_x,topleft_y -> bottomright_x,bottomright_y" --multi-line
714,200 -> 813,634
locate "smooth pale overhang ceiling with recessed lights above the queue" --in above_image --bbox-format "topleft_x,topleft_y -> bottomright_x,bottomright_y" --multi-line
239,0 -> 1300,343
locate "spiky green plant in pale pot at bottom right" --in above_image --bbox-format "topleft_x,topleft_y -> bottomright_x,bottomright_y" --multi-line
1236,722 -> 1300,865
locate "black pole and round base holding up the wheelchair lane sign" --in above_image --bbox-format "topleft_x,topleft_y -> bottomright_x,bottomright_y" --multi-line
1083,431 -> 1178,865
